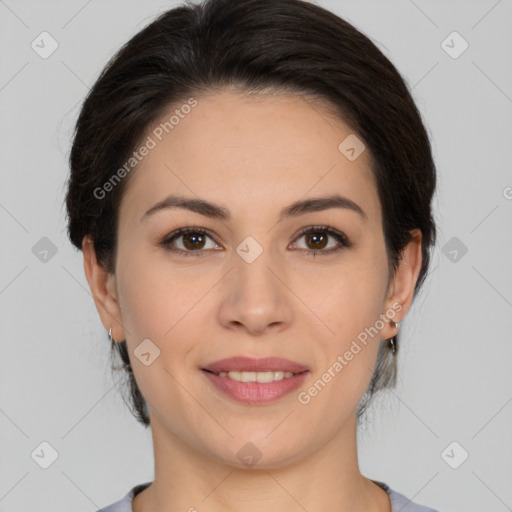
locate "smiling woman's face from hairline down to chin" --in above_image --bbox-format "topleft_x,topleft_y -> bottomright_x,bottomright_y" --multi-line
86,91 -> 419,467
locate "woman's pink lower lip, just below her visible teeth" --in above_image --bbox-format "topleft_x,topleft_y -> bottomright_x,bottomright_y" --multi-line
202,370 -> 309,404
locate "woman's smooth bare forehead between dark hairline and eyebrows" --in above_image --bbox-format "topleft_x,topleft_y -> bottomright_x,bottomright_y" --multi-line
121,91 -> 379,227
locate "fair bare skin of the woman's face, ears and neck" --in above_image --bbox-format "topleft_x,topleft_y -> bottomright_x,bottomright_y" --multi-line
83,91 -> 421,512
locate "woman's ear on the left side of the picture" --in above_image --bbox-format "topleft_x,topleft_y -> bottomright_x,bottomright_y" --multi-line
82,235 -> 125,341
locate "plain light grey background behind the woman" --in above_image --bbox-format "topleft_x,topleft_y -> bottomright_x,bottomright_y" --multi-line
0,0 -> 512,512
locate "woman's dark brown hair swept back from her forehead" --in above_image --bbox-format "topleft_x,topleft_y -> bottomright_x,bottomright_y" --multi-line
66,0 -> 436,426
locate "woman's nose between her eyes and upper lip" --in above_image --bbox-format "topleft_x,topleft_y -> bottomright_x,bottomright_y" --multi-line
218,247 -> 293,336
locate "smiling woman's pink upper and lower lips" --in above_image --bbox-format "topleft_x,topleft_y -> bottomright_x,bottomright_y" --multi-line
202,357 -> 309,404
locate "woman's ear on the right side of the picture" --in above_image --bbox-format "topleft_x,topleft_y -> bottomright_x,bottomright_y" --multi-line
381,229 -> 422,340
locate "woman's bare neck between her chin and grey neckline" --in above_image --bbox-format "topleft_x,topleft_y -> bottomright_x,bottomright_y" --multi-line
132,417 -> 391,512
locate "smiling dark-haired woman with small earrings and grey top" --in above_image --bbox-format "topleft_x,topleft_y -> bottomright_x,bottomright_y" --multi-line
67,0 -> 435,512
